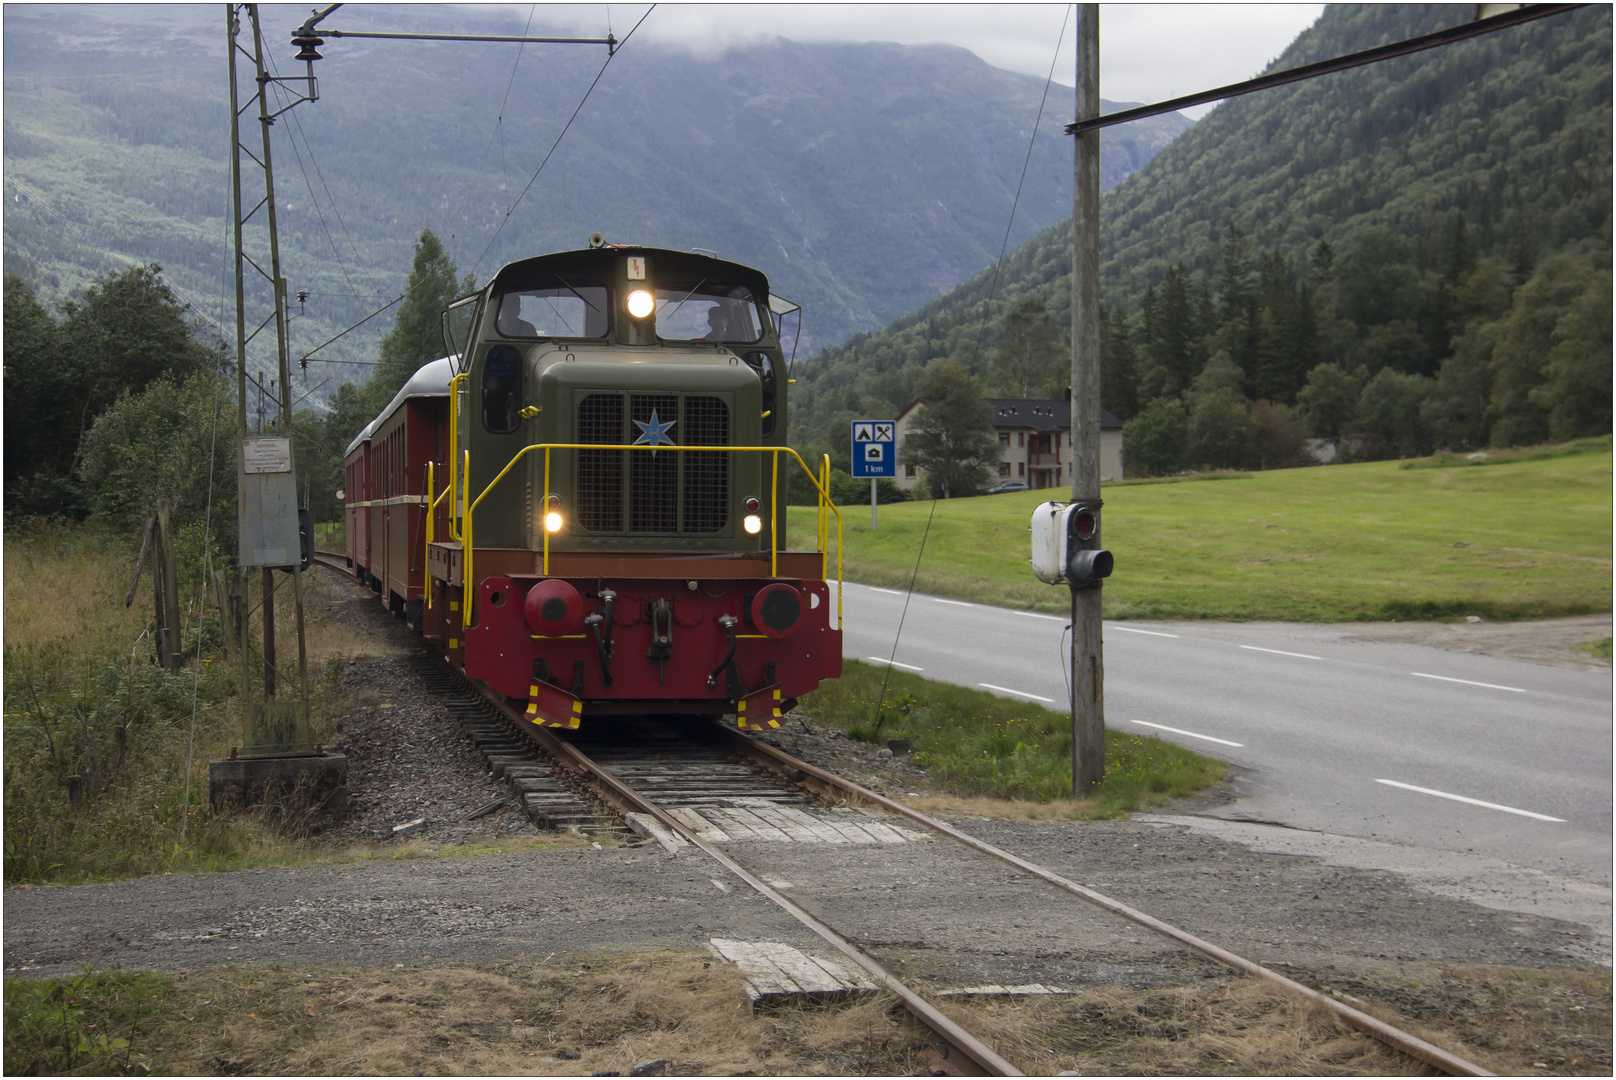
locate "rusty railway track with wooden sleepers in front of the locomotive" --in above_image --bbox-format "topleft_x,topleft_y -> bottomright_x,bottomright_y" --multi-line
317,551 -> 1493,1077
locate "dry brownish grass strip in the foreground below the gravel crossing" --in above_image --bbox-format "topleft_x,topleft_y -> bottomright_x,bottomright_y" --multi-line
5,952 -> 1611,1075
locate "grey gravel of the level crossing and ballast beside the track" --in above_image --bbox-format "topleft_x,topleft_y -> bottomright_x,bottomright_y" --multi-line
5,576 -> 1610,1060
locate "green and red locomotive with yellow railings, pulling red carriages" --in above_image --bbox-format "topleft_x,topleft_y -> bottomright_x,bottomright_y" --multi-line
344,242 -> 842,731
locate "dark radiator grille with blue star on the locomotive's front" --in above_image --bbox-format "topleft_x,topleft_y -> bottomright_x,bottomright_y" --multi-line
577,393 -> 730,535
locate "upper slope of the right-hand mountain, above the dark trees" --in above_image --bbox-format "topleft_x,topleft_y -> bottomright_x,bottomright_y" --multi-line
795,5 -> 1611,445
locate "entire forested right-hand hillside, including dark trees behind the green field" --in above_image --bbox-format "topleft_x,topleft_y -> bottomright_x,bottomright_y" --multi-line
795,5 -> 1611,472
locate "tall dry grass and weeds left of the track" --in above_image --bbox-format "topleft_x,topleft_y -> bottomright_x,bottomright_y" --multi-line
3,527 -> 407,884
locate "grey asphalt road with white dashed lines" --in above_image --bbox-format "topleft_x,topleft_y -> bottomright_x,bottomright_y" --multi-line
844,582 -> 1611,889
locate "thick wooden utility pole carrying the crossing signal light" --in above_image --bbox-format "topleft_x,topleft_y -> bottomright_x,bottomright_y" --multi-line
1071,3 -> 1105,799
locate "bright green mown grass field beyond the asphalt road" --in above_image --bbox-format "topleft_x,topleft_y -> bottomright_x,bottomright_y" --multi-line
790,437 -> 1611,622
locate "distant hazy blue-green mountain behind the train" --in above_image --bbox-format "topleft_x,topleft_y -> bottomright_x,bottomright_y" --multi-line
5,5 -> 1189,386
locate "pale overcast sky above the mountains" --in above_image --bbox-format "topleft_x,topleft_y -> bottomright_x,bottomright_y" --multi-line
491,3 -> 1324,116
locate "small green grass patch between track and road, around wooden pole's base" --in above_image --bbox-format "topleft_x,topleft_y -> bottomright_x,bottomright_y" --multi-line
803,660 -> 1227,818
